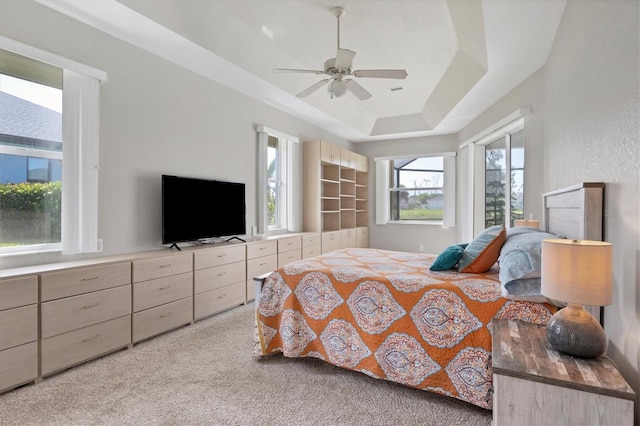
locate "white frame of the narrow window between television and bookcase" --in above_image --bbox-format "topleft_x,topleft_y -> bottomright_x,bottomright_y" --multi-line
256,125 -> 302,235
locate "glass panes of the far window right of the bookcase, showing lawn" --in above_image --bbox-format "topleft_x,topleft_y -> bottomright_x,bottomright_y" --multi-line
389,157 -> 444,221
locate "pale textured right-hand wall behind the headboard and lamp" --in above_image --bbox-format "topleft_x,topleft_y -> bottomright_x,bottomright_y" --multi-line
544,0 -> 640,424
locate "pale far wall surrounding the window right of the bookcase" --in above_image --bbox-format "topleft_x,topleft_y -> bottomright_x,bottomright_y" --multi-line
354,135 -> 458,253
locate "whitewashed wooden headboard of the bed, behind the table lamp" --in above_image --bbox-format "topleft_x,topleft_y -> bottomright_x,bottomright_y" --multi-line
542,182 -> 604,325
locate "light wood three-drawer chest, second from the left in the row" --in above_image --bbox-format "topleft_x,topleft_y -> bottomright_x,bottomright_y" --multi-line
40,262 -> 131,376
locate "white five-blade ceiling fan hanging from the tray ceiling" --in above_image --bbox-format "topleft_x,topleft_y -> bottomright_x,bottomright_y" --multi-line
273,7 -> 407,101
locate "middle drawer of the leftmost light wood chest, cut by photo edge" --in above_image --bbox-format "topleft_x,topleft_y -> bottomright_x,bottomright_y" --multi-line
0,305 -> 38,350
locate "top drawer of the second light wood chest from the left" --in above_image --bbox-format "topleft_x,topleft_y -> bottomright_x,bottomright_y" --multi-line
40,262 -> 131,302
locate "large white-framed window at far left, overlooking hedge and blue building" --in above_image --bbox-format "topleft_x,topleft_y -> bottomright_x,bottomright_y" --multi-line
0,37 -> 106,254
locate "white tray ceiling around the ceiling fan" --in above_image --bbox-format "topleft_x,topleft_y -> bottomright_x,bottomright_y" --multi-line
36,0 -> 566,142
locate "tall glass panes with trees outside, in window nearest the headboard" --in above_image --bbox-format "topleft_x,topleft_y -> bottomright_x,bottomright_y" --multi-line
484,129 -> 524,227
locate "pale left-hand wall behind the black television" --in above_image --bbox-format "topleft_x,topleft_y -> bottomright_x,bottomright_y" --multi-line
0,0 -> 351,268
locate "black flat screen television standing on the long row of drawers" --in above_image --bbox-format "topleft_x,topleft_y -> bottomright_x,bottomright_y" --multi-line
162,175 -> 246,249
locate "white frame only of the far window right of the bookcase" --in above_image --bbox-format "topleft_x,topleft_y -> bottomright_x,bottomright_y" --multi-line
374,152 -> 456,227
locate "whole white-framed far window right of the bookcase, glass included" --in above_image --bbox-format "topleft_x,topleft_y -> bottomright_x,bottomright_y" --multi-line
376,154 -> 455,226
